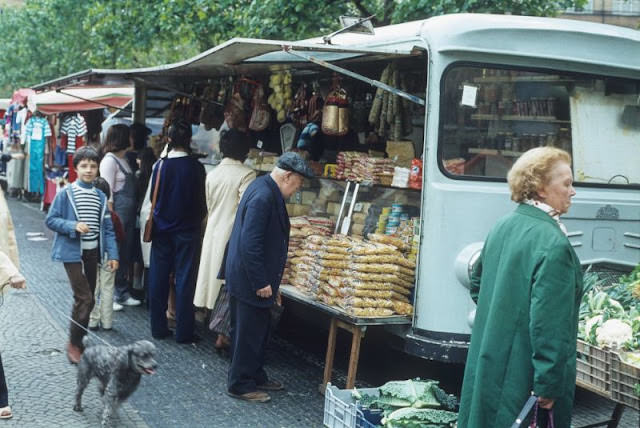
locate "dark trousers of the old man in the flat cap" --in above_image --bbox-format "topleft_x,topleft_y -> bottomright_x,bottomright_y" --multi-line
227,295 -> 271,394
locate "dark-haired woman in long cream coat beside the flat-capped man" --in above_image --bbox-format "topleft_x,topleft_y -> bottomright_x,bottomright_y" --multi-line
193,129 -> 256,349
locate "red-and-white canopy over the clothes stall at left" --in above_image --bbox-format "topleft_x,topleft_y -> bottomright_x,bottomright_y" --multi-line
30,87 -> 134,114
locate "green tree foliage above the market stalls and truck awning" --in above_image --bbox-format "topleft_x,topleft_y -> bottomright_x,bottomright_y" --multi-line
0,0 -> 585,96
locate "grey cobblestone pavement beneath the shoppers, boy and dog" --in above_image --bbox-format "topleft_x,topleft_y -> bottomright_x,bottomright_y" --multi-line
0,199 -> 638,428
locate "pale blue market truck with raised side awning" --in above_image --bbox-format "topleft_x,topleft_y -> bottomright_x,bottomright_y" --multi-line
36,14 -> 640,362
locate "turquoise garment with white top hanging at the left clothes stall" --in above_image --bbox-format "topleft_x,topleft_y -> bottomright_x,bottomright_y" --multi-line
25,115 -> 51,195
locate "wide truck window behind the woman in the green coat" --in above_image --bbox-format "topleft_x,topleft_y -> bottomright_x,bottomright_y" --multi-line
439,65 -> 640,186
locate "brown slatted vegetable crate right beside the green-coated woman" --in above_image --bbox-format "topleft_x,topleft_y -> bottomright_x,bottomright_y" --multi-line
576,340 -> 611,395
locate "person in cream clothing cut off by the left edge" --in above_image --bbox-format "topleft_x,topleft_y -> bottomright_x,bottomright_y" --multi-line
0,189 -> 26,419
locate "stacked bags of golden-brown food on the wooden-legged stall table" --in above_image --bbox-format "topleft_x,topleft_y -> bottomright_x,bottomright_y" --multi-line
290,235 -> 415,317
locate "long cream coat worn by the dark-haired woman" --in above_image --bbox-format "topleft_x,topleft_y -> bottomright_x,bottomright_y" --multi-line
193,158 -> 256,309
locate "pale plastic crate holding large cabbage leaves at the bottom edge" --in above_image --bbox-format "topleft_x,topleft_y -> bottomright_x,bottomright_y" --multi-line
323,383 -> 378,428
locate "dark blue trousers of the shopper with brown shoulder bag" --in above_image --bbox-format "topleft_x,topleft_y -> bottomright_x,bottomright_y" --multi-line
149,230 -> 200,342
